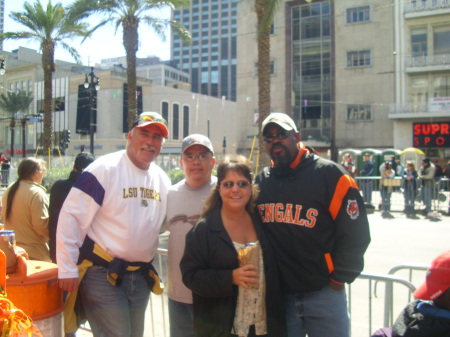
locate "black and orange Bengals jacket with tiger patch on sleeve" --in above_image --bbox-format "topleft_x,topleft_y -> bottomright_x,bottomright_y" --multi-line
255,151 -> 370,294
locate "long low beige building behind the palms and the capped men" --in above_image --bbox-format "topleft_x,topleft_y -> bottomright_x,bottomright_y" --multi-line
0,48 -> 237,165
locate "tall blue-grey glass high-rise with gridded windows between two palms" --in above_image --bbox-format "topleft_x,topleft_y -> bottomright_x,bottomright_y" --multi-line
171,0 -> 238,101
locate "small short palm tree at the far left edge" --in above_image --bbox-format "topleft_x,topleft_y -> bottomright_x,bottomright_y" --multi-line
0,90 -> 33,157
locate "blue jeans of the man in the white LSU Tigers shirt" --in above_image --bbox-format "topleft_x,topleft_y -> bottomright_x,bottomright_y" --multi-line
80,266 -> 150,337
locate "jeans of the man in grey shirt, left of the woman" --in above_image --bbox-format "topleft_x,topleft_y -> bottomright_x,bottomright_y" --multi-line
169,298 -> 194,337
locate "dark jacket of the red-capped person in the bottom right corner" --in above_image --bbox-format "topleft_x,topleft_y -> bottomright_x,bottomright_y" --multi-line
392,301 -> 450,337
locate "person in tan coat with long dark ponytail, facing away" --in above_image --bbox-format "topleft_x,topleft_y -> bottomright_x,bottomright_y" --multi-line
2,157 -> 50,261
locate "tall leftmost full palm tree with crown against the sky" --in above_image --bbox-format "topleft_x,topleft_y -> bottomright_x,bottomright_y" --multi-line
0,0 -> 88,158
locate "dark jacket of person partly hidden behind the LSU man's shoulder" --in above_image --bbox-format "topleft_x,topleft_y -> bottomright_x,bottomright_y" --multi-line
48,171 -> 81,263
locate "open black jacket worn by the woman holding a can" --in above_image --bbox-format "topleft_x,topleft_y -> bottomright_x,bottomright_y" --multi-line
180,209 -> 286,337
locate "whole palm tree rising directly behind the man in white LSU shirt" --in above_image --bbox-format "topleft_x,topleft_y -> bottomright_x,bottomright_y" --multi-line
69,0 -> 191,129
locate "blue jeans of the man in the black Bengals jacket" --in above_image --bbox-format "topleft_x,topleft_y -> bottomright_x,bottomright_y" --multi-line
284,286 -> 350,337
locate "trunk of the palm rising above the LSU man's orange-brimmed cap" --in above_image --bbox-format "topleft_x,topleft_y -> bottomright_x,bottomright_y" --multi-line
123,17 -> 139,130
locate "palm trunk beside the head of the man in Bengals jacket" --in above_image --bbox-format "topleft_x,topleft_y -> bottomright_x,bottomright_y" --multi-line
255,0 -> 271,170
